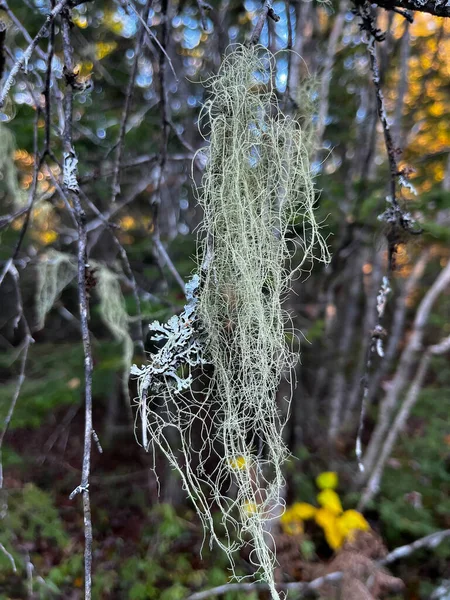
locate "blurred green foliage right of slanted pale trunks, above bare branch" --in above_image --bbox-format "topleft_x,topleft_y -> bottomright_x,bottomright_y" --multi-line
378,386 -> 450,552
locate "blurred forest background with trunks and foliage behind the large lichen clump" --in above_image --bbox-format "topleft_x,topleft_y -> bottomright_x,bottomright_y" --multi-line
0,0 -> 450,600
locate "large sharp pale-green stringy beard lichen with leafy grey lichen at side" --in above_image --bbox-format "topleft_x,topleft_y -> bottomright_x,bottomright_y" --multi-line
134,46 -> 328,598
